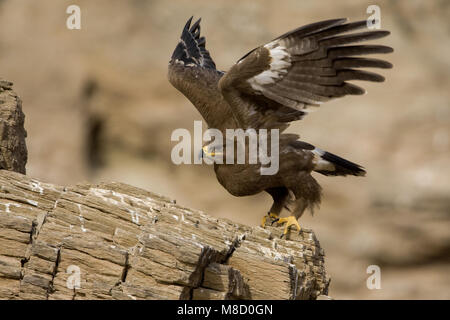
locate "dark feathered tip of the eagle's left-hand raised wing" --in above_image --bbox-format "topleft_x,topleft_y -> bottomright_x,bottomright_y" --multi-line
172,17 -> 216,69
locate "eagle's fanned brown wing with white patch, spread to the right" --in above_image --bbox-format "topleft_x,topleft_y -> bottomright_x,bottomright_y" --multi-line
219,19 -> 393,130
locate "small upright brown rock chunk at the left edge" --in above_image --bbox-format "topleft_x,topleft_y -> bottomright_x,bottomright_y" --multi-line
0,80 -> 28,173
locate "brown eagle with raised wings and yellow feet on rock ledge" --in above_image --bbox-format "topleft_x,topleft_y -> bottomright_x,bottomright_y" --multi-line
168,17 -> 393,237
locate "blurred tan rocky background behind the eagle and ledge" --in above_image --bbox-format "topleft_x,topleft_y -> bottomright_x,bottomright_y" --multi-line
0,0 -> 450,299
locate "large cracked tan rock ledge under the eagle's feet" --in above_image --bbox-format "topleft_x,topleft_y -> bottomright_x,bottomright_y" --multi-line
0,170 -> 329,299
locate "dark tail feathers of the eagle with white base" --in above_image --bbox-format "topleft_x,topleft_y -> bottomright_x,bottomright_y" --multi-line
312,148 -> 366,176
